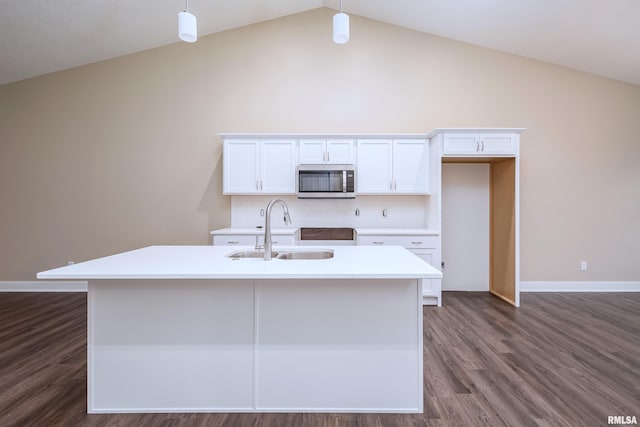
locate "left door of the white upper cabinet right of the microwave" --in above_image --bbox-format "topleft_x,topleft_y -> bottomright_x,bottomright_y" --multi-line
356,139 -> 393,194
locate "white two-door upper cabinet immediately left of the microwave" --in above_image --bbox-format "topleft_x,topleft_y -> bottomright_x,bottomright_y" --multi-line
223,139 -> 296,194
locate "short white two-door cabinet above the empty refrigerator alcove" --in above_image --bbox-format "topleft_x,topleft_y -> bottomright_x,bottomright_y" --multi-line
443,133 -> 518,157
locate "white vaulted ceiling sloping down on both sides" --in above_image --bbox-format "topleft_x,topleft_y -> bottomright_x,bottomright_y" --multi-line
0,0 -> 640,85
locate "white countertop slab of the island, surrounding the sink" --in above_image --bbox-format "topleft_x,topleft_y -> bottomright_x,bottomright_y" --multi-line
37,245 -> 442,280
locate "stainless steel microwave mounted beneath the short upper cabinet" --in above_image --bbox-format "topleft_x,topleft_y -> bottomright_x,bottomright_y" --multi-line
296,165 -> 356,199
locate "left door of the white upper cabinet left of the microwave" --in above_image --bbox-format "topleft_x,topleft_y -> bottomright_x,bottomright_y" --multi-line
223,140 -> 260,194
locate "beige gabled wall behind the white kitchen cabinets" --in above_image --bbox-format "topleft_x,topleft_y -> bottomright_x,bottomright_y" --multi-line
0,9 -> 640,281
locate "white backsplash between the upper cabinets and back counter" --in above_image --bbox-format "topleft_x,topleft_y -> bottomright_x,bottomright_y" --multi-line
230,196 -> 430,228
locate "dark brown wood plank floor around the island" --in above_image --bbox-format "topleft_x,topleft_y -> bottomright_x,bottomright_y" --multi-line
0,292 -> 640,427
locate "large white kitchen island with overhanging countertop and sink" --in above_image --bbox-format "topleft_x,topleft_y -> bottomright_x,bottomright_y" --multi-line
38,246 -> 441,413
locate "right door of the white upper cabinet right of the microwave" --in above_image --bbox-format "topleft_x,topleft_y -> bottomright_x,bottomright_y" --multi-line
393,140 -> 429,194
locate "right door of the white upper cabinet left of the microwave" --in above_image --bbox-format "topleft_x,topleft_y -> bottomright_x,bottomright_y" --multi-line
260,140 -> 296,194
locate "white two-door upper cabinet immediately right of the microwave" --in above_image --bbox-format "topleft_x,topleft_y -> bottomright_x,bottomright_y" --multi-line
356,139 -> 429,194
